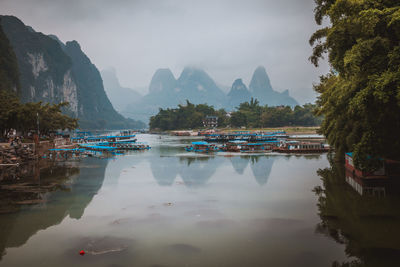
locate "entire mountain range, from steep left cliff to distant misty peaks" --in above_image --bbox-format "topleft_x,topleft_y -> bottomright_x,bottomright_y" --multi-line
0,16 -> 297,129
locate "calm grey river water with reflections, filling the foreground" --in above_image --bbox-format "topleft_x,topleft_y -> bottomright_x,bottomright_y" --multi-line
0,135 -> 400,267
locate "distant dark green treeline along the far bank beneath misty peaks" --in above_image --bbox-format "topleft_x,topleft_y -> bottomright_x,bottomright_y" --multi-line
150,99 -> 322,130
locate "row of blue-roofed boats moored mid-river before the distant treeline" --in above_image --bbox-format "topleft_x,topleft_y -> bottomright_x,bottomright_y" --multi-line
185,132 -> 329,153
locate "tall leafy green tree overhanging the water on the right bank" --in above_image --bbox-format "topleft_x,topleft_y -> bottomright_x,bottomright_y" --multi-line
310,0 -> 400,169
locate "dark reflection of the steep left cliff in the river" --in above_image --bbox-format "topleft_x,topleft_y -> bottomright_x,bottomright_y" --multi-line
0,158 -> 107,257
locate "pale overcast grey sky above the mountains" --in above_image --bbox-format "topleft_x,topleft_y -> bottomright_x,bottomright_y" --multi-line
0,0 -> 328,102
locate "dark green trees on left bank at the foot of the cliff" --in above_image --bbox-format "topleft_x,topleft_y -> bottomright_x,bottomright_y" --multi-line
0,90 -> 78,136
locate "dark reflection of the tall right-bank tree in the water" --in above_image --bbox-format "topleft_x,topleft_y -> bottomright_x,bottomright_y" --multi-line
314,160 -> 400,267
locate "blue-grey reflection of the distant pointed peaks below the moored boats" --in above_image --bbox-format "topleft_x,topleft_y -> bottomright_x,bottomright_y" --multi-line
150,155 -> 275,187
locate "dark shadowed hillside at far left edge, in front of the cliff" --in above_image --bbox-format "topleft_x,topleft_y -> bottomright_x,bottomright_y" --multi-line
0,18 -> 19,93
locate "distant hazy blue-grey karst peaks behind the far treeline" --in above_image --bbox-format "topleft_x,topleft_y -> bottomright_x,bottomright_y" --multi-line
102,66 -> 298,122
